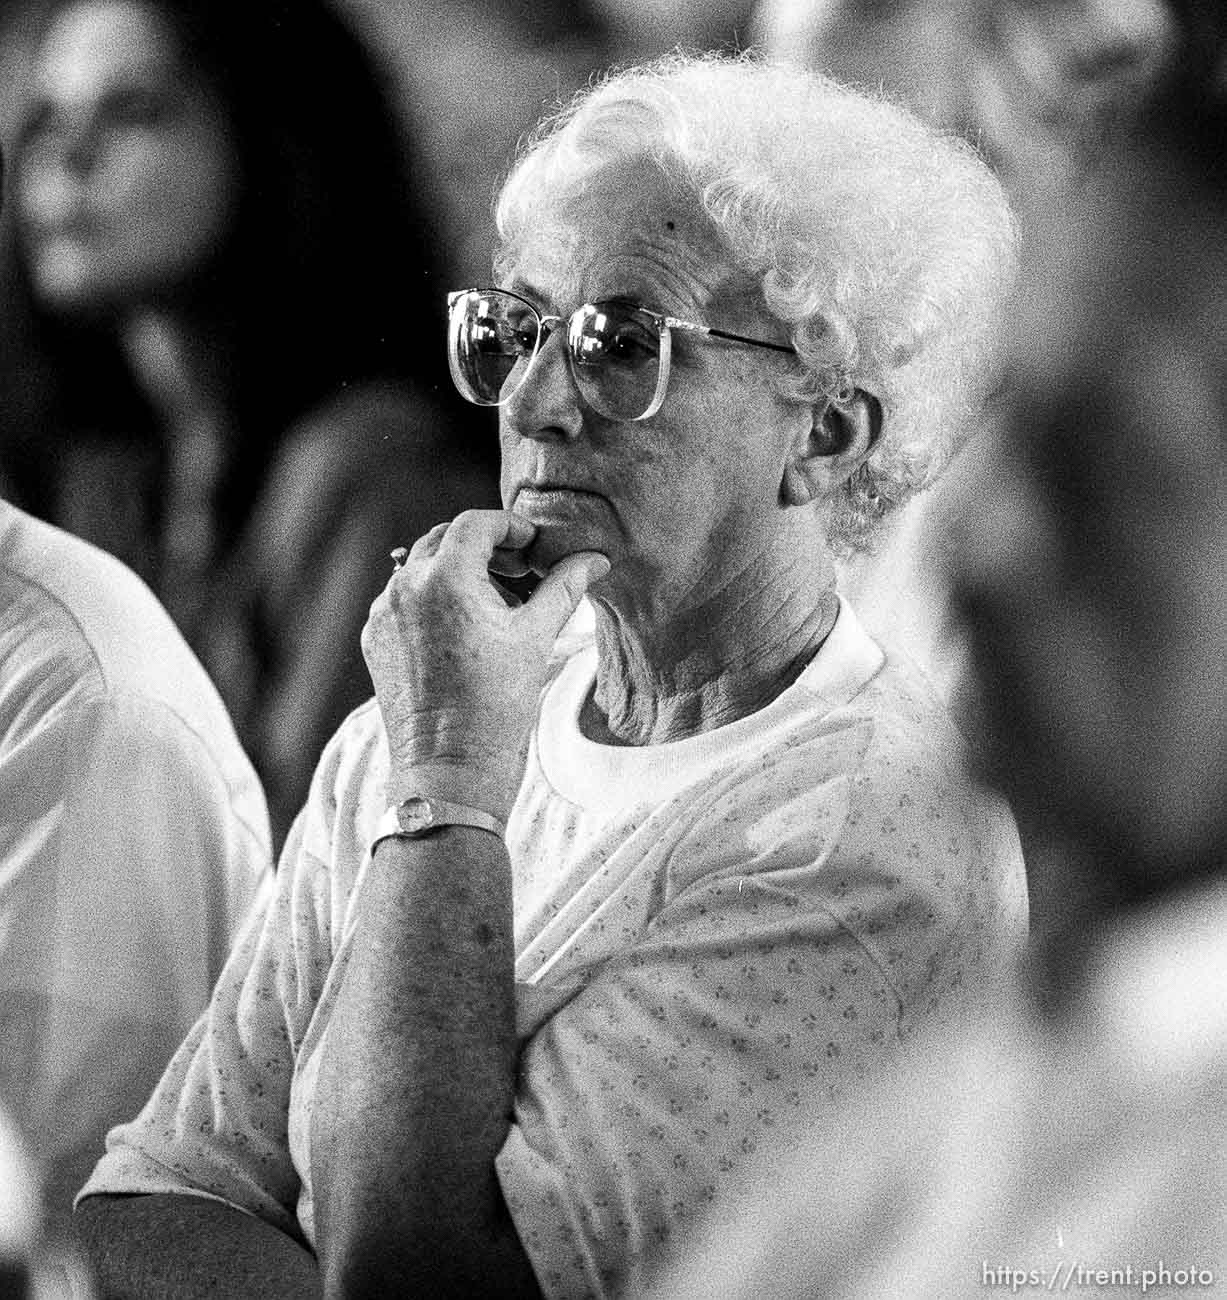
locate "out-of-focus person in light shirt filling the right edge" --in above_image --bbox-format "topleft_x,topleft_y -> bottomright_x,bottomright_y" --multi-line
663,0 -> 1227,1300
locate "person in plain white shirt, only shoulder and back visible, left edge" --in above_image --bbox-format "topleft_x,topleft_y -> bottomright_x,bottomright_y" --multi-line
0,126 -> 272,1231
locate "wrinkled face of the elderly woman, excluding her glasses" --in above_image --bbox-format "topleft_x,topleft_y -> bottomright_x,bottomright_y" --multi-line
499,163 -> 810,601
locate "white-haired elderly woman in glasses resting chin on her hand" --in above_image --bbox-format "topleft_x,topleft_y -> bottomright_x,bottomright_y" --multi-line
79,59 -> 1026,1296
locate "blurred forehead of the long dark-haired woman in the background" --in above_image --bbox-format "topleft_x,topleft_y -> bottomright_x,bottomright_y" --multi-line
38,0 -> 177,99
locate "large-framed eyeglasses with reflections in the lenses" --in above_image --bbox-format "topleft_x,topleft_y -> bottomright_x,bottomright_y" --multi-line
447,289 -> 795,420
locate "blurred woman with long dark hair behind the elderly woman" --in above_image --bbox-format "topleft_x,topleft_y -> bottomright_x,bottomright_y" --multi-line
0,0 -> 494,840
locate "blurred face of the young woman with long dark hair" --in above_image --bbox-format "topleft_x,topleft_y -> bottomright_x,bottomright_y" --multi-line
17,0 -> 238,311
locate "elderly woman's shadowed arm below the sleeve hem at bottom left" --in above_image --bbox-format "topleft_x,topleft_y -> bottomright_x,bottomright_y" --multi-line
74,1196 -> 320,1300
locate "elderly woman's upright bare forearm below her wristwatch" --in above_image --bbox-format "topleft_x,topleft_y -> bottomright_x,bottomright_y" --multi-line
312,827 -> 537,1296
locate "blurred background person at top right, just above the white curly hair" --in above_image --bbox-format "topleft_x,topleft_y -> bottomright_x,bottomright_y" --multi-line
751,0 -> 1172,205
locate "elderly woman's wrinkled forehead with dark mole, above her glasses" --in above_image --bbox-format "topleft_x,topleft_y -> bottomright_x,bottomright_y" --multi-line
502,159 -> 740,316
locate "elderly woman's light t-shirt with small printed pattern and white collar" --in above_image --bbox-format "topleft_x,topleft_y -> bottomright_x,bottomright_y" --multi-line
84,595 -> 1026,1297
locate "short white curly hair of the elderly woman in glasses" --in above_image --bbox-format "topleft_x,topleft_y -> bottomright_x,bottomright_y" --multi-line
495,53 -> 1018,553
